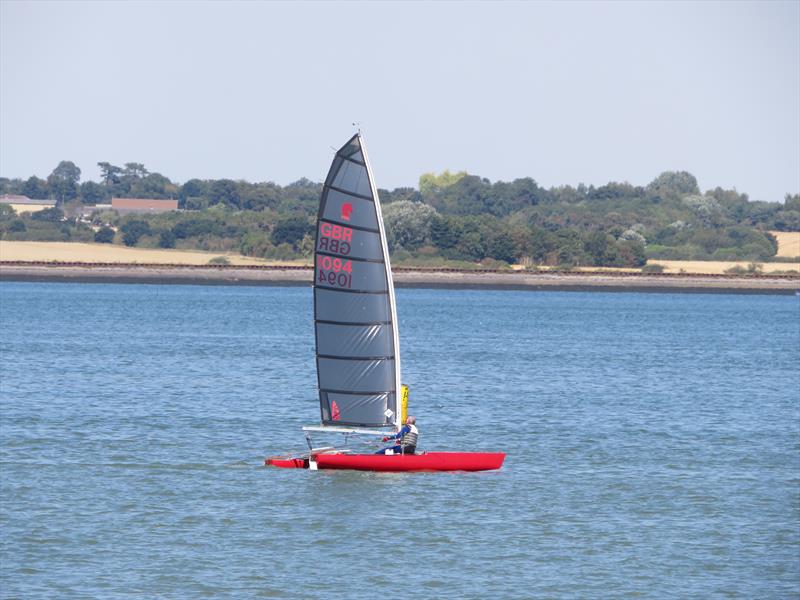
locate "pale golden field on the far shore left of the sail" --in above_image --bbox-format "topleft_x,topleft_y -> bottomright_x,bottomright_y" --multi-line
0,241 -> 300,265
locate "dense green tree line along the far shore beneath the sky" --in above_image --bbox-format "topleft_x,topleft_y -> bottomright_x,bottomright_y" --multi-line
0,161 -> 800,266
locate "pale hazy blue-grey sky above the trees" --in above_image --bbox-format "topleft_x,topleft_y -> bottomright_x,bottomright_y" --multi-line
0,0 -> 800,201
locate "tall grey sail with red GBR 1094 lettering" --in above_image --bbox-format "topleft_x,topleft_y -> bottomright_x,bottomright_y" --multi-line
314,134 -> 400,428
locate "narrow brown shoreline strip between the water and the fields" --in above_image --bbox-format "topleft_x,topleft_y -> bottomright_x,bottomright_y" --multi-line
0,263 -> 800,295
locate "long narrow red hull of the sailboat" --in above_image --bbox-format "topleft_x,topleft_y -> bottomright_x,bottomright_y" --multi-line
266,452 -> 506,472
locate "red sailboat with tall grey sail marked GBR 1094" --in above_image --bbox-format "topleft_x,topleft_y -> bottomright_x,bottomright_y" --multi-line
265,131 -> 505,471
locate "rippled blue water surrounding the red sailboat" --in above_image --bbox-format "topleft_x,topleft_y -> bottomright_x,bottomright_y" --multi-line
0,283 -> 800,598
